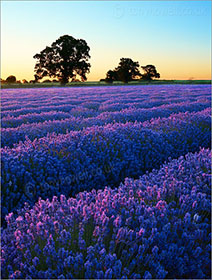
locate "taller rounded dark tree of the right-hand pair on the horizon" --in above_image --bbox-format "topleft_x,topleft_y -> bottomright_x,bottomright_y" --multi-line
115,58 -> 141,83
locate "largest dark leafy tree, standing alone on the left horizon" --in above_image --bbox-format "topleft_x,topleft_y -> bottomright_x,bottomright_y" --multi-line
33,35 -> 90,84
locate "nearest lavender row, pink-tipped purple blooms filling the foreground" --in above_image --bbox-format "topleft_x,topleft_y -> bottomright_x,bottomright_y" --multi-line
1,149 -> 211,279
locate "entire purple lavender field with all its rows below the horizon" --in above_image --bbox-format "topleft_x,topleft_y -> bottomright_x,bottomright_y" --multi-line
1,85 -> 211,279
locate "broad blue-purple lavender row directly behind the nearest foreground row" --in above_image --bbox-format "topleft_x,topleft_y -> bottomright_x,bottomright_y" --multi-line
1,109 -> 211,217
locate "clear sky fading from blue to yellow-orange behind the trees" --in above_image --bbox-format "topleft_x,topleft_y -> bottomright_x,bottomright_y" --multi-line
1,1 -> 211,81
